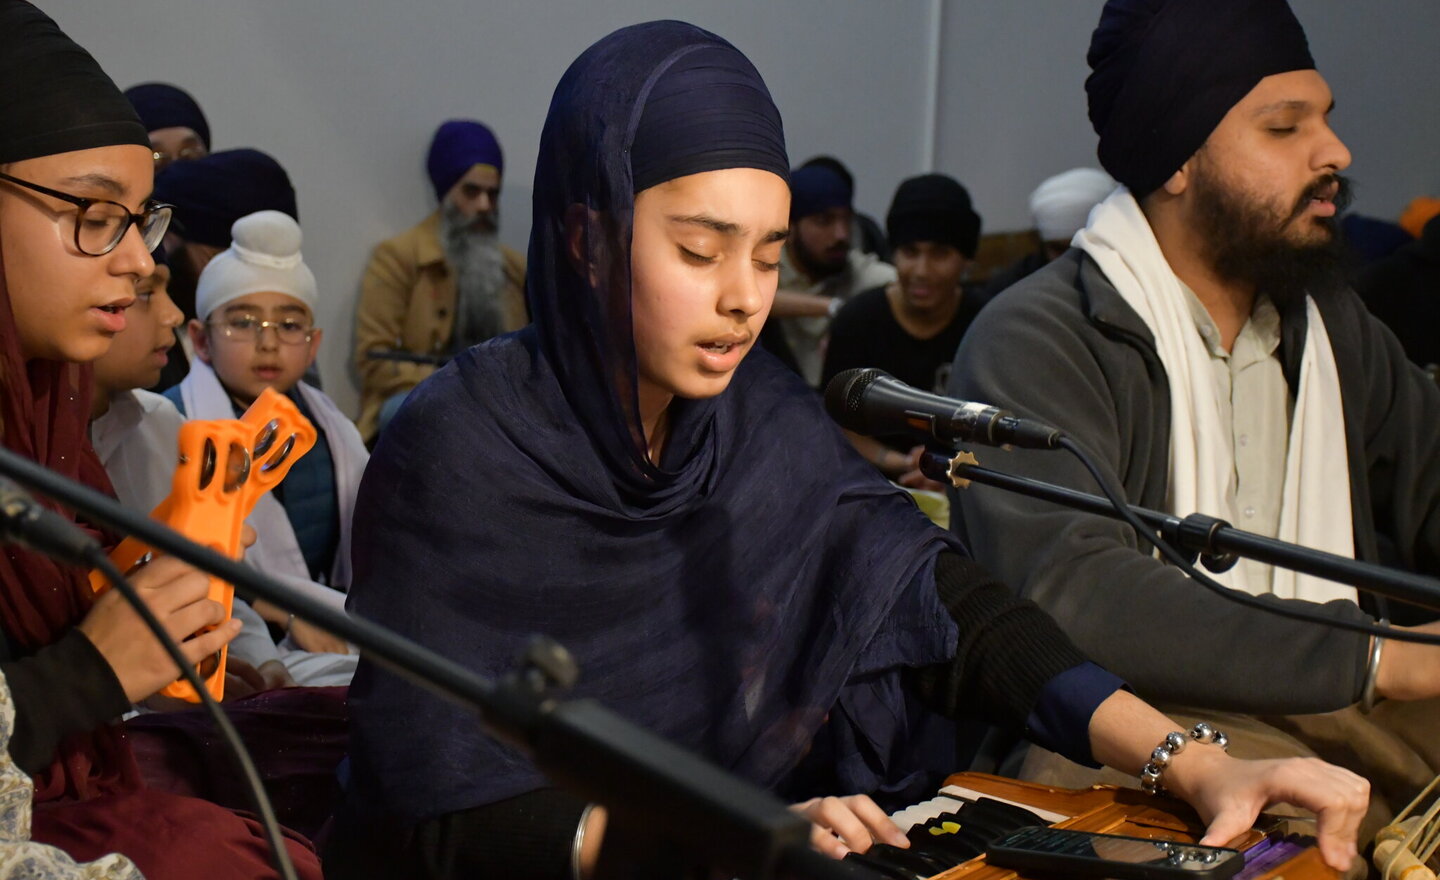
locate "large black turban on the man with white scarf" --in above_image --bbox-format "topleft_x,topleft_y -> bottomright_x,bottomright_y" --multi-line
1084,0 -> 1315,199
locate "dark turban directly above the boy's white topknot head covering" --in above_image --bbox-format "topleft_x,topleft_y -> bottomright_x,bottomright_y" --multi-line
147,149 -> 300,248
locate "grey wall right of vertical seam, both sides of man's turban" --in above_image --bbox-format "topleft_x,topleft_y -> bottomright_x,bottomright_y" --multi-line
936,0 -> 1440,230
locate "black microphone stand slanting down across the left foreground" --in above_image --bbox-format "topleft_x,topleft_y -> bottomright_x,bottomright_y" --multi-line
0,446 -> 868,879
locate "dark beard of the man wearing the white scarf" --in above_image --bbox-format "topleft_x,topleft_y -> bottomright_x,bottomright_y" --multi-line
1192,166 -> 1352,311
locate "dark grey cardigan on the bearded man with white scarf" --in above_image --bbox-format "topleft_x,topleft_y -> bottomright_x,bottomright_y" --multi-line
949,249 -> 1440,714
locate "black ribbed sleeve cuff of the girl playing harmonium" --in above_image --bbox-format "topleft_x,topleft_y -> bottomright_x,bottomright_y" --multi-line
917,552 -> 1087,730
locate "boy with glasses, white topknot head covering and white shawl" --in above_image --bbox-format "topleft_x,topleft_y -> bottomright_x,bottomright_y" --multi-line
166,210 -> 369,654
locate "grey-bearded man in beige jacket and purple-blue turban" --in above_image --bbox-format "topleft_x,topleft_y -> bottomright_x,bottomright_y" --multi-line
356,120 -> 528,445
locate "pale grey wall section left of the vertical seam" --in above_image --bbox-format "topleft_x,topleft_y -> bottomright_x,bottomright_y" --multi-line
61,0 -> 927,413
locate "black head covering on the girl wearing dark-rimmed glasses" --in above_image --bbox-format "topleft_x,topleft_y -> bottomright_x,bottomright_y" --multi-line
0,0 -> 150,163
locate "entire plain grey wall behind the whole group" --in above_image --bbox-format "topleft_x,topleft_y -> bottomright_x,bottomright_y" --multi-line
61,0 -> 1440,415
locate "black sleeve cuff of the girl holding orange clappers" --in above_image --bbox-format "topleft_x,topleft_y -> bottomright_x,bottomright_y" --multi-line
0,629 -> 130,776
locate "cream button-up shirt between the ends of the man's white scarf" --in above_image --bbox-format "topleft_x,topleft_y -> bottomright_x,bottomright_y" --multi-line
1176,289 -> 1292,591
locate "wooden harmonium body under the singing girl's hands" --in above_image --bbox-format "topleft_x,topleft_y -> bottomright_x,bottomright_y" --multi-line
847,773 -> 1338,880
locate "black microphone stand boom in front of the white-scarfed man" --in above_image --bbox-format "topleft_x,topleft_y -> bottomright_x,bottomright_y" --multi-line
920,452 -> 1440,609
